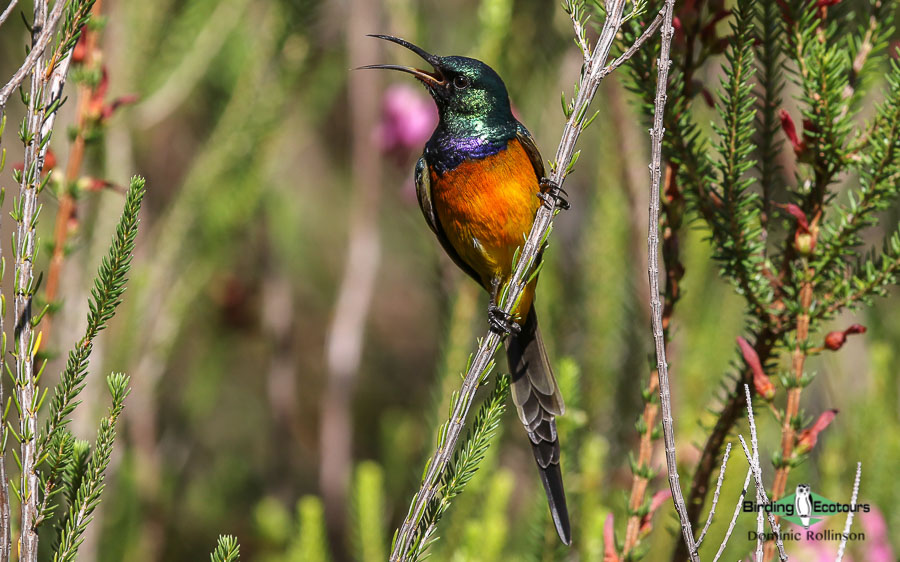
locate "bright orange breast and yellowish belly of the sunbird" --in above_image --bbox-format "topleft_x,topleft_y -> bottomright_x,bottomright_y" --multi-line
431,139 -> 541,318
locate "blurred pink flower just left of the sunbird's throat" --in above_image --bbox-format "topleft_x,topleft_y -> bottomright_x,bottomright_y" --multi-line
375,84 -> 438,160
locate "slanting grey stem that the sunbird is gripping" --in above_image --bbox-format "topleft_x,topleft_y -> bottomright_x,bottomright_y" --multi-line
390,0 -> 625,562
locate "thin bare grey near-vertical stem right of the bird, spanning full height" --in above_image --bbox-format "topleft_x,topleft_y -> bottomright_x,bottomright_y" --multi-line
647,0 -> 700,562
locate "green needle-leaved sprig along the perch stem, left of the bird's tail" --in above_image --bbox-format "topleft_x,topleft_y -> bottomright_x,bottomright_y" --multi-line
410,375 -> 509,560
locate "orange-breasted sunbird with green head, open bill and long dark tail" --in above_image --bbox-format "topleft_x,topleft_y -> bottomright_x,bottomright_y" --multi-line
362,35 -> 572,545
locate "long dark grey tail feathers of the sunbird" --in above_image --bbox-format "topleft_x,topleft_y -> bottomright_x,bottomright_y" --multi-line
506,308 -> 572,545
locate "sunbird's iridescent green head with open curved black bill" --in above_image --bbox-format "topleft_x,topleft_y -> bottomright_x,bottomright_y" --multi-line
362,35 -> 516,135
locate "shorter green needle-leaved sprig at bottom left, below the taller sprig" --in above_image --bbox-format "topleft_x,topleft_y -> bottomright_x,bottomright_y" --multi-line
53,373 -> 130,562
